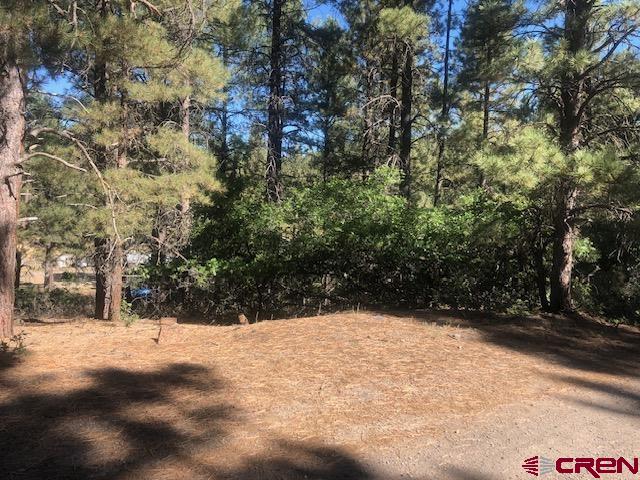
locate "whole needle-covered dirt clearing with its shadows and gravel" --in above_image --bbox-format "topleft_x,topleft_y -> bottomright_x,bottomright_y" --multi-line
0,311 -> 640,480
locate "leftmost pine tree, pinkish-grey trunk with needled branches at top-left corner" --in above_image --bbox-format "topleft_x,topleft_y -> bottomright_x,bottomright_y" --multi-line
0,0 -> 65,337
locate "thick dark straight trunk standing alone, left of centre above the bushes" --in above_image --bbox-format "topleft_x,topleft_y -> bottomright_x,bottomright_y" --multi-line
266,0 -> 286,202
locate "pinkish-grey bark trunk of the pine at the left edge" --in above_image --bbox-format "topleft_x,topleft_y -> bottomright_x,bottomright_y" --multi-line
0,60 -> 25,338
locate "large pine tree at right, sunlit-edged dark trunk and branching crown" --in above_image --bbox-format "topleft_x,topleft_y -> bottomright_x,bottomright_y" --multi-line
534,0 -> 640,311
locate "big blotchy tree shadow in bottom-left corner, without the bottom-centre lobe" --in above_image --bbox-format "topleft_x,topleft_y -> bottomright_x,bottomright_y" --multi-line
0,364 -> 229,480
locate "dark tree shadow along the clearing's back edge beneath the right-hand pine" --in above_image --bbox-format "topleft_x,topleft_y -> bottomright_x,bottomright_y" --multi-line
380,310 -> 640,377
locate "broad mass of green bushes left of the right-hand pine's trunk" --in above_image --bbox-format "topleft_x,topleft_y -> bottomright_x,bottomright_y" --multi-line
174,169 -> 537,313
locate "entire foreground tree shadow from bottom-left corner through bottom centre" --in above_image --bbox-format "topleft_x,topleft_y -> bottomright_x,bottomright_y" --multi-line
0,362 -> 416,480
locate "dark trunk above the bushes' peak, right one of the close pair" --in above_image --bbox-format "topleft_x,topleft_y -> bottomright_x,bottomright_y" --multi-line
400,42 -> 413,198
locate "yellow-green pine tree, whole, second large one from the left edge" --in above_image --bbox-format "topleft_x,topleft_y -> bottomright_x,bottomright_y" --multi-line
32,0 -> 224,320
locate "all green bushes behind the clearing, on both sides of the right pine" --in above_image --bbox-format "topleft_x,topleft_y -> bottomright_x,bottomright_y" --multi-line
142,169 -> 640,319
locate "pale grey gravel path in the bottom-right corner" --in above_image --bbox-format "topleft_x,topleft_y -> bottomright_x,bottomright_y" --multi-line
370,378 -> 640,480
